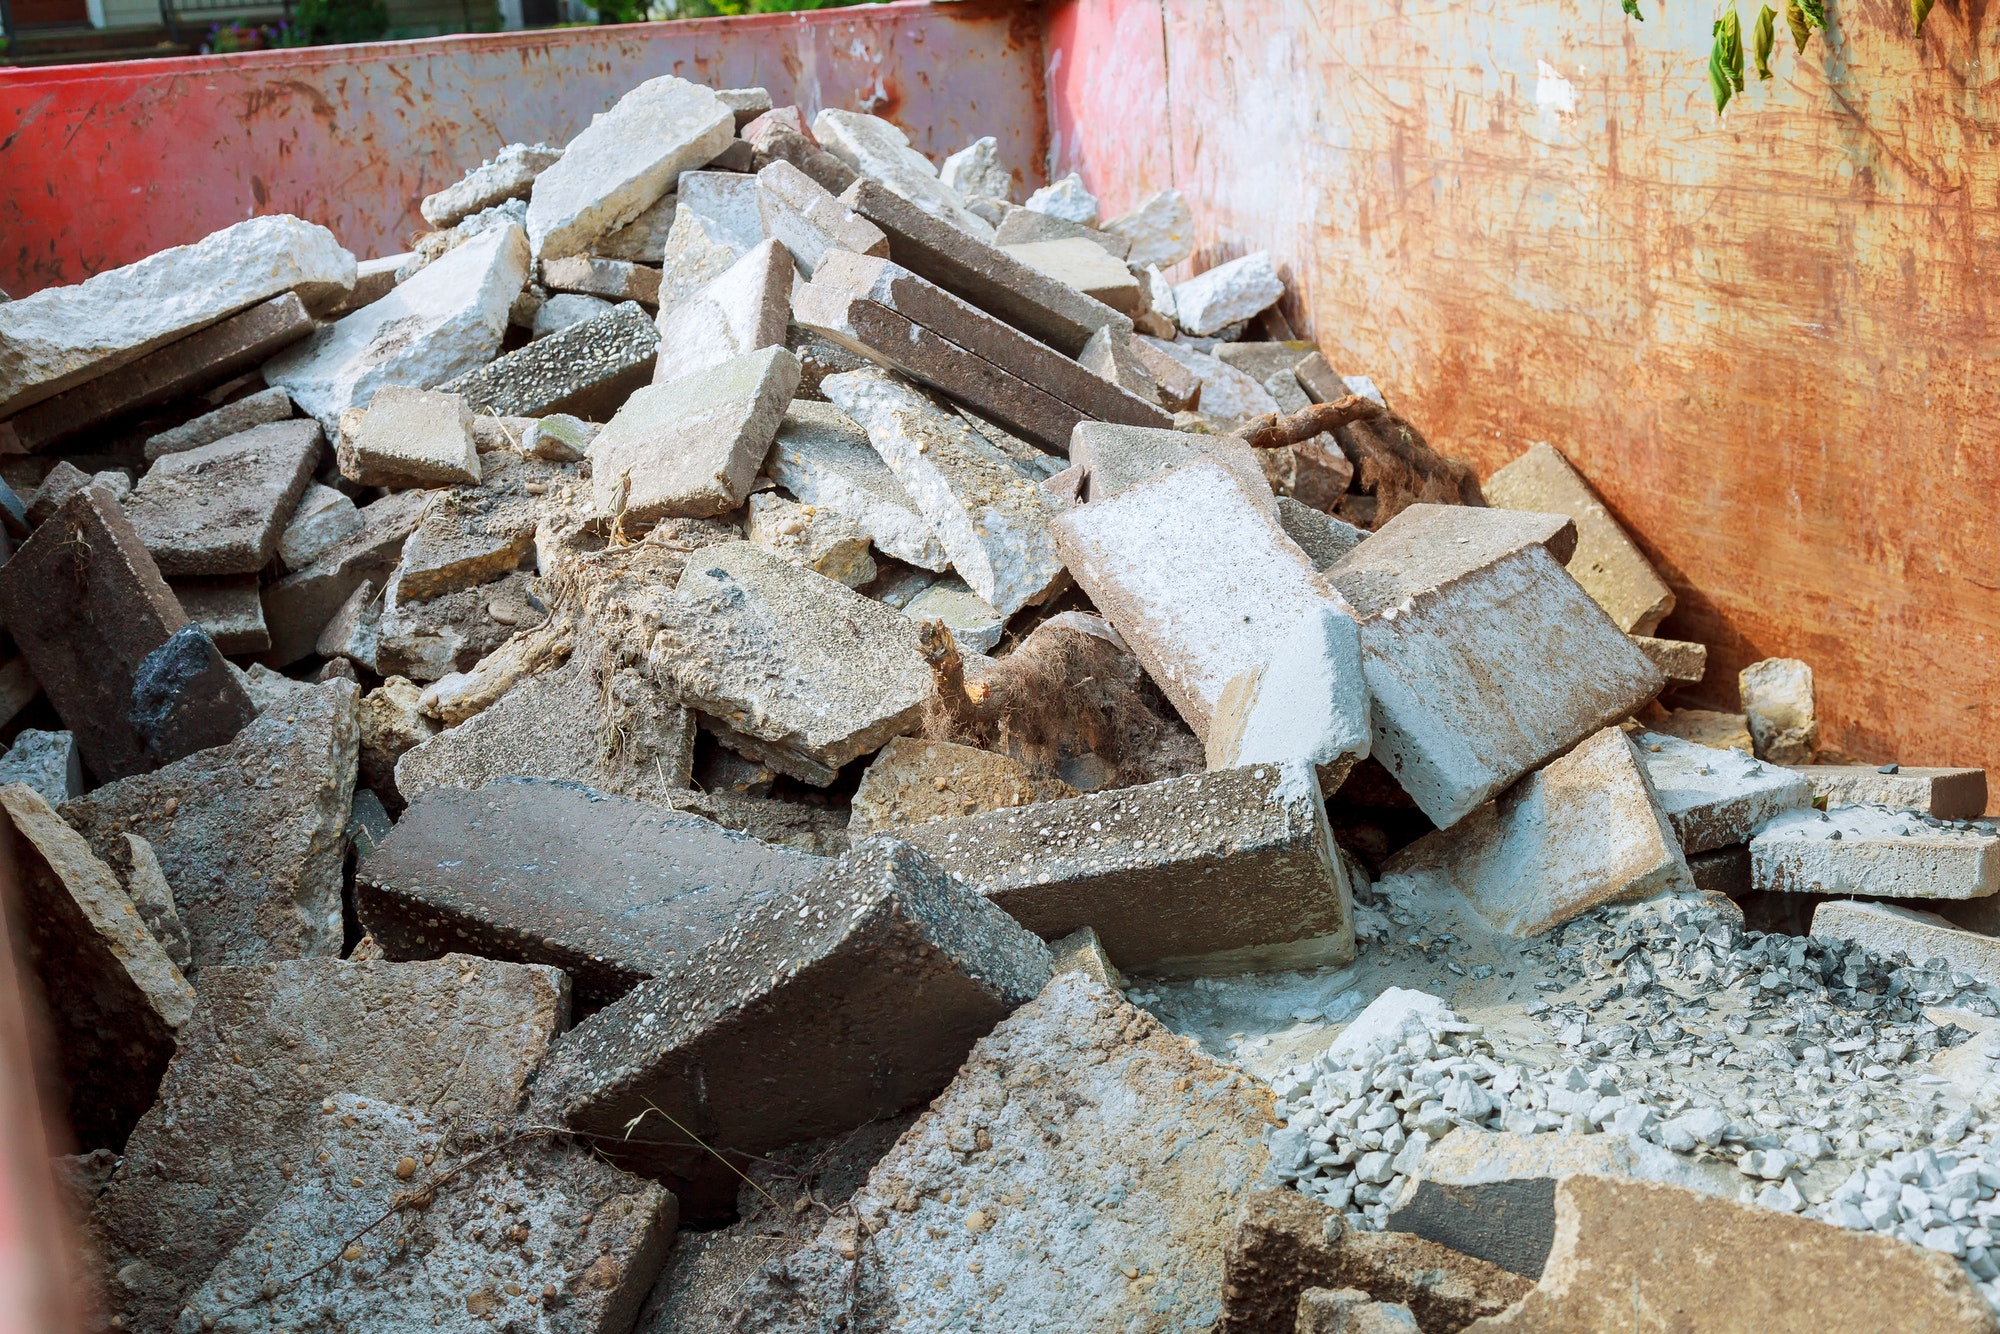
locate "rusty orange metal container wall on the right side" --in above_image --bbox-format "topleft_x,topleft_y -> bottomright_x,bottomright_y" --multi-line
1044,0 -> 2000,792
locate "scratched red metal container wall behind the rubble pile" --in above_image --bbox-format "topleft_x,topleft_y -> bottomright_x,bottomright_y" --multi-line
0,0 -> 1046,296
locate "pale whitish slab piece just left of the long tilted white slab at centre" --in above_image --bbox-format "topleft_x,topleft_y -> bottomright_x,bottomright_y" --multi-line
764,400 -> 950,570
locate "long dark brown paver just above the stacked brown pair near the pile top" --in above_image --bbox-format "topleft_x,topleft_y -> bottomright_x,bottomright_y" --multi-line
840,178 -> 1132,356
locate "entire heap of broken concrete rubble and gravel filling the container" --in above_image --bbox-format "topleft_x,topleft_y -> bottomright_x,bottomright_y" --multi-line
0,78 -> 2000,1334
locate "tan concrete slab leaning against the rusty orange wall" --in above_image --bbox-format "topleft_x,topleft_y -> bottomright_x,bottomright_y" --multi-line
1480,444 -> 1674,634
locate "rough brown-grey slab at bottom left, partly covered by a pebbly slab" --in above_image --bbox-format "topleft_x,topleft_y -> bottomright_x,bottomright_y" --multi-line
90,954 -> 568,1330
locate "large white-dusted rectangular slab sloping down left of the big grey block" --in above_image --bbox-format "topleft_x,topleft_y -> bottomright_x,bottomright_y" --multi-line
1050,458 -> 1370,772
